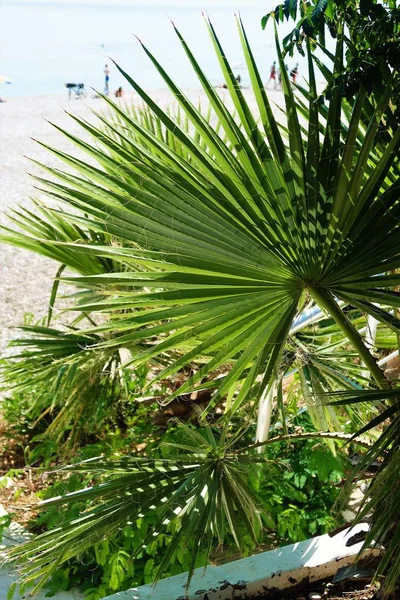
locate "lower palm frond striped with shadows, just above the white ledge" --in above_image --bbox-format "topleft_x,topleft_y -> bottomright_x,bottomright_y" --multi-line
8,425 -> 267,592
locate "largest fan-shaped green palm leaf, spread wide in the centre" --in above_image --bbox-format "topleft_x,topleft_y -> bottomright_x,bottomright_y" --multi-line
3,18 -> 400,410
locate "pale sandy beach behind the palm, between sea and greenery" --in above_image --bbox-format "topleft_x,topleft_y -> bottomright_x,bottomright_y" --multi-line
0,90 -> 283,356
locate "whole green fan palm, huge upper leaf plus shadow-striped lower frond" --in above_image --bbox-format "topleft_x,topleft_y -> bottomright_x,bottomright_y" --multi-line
2,14 -> 400,596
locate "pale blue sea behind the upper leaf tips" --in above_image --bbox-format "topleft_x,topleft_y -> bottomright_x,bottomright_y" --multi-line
0,0 -> 305,97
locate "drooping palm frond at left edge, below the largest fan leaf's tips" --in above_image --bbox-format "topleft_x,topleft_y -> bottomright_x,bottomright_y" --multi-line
1,326 -> 127,445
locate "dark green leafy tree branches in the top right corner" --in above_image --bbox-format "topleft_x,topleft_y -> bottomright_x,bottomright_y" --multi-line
262,0 -> 400,109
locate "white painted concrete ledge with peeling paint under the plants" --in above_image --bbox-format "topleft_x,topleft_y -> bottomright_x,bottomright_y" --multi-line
105,523 -> 380,600
